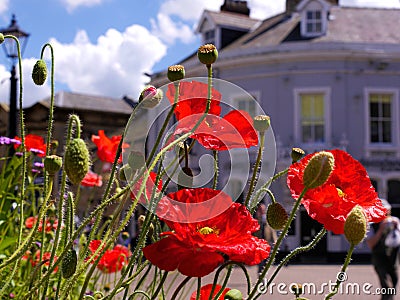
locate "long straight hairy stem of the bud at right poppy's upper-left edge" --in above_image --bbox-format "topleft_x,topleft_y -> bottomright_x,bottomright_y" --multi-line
248,188 -> 308,300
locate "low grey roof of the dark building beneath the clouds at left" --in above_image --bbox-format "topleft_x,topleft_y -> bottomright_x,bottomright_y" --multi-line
39,91 -> 132,115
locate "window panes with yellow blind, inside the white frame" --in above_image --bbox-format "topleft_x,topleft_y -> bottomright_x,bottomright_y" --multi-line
300,93 -> 325,143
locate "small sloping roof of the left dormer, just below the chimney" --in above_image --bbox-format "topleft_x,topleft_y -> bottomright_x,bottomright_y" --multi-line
196,10 -> 260,32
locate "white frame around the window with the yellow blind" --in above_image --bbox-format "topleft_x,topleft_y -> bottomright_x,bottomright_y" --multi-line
293,87 -> 331,151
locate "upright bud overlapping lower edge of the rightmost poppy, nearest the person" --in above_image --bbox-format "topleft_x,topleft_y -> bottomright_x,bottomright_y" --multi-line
344,205 -> 367,245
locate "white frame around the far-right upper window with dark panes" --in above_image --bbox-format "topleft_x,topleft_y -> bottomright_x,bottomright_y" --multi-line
364,87 -> 400,157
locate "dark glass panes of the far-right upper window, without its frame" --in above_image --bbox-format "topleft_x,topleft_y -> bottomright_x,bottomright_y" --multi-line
369,93 -> 393,143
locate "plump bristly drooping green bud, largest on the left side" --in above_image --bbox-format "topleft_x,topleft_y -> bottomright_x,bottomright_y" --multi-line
64,138 -> 90,184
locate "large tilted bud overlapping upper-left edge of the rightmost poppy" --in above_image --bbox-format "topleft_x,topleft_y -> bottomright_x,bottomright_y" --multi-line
303,151 -> 335,189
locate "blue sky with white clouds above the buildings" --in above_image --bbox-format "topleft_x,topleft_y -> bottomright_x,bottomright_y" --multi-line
0,0 -> 400,107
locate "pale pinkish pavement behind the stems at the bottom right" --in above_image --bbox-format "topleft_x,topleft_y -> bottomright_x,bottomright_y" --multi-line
162,264 -> 400,300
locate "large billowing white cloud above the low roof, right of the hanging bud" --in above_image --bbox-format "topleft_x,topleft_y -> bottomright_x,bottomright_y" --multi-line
50,25 -> 166,98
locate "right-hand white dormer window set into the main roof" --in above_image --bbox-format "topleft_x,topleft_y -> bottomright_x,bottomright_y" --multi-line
297,0 -> 329,38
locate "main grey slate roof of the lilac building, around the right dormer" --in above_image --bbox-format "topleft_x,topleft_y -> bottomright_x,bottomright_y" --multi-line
225,6 -> 400,50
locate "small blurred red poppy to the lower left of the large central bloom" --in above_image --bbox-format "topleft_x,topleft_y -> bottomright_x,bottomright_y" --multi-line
89,240 -> 132,273
